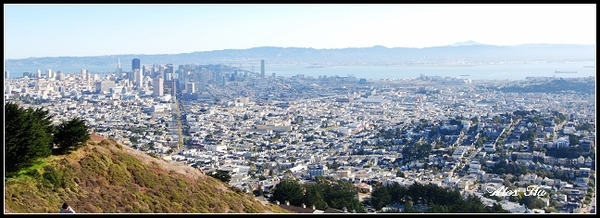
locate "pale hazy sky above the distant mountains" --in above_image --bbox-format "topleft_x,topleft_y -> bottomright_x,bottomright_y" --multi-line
4,4 -> 596,59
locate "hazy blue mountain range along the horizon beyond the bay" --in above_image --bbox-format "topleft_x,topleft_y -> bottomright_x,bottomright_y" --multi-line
5,41 -> 596,67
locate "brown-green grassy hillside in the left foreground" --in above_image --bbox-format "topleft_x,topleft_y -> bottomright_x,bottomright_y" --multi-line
4,137 -> 287,213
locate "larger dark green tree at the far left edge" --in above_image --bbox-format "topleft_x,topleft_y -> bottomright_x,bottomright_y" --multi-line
4,102 -> 54,175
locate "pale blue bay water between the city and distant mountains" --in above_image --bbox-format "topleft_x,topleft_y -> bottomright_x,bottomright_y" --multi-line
4,61 -> 596,80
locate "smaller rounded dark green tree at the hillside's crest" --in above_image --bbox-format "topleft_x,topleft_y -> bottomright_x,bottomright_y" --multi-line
54,118 -> 90,154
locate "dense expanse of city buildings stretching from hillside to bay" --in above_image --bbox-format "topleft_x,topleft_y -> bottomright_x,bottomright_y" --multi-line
4,59 -> 596,213
